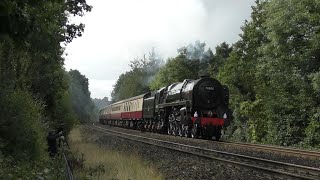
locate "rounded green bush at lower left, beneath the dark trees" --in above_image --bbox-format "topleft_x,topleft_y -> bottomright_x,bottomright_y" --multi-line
0,90 -> 46,161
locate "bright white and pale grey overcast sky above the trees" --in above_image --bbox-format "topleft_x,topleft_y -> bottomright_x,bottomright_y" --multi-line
65,0 -> 254,98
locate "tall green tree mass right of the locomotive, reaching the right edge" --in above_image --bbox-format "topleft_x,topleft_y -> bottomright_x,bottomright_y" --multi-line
219,0 -> 320,146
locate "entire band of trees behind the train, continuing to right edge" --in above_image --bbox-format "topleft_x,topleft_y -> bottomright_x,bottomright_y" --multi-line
113,0 -> 320,147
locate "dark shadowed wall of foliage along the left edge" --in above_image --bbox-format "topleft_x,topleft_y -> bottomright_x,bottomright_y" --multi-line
0,0 -> 91,179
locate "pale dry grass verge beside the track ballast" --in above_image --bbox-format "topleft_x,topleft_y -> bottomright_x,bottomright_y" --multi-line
69,128 -> 164,180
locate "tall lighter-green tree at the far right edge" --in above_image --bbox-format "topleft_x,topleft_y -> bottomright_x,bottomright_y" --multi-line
256,0 -> 320,146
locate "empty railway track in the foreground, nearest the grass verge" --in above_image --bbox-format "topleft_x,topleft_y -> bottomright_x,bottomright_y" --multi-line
87,125 -> 320,179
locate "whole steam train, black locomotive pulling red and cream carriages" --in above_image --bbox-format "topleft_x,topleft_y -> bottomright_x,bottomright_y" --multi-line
99,76 -> 229,140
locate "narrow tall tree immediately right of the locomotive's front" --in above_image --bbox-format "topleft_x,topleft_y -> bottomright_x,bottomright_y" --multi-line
218,0 -> 268,141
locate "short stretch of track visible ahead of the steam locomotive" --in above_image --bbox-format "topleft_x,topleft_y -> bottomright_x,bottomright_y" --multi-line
215,141 -> 320,160
